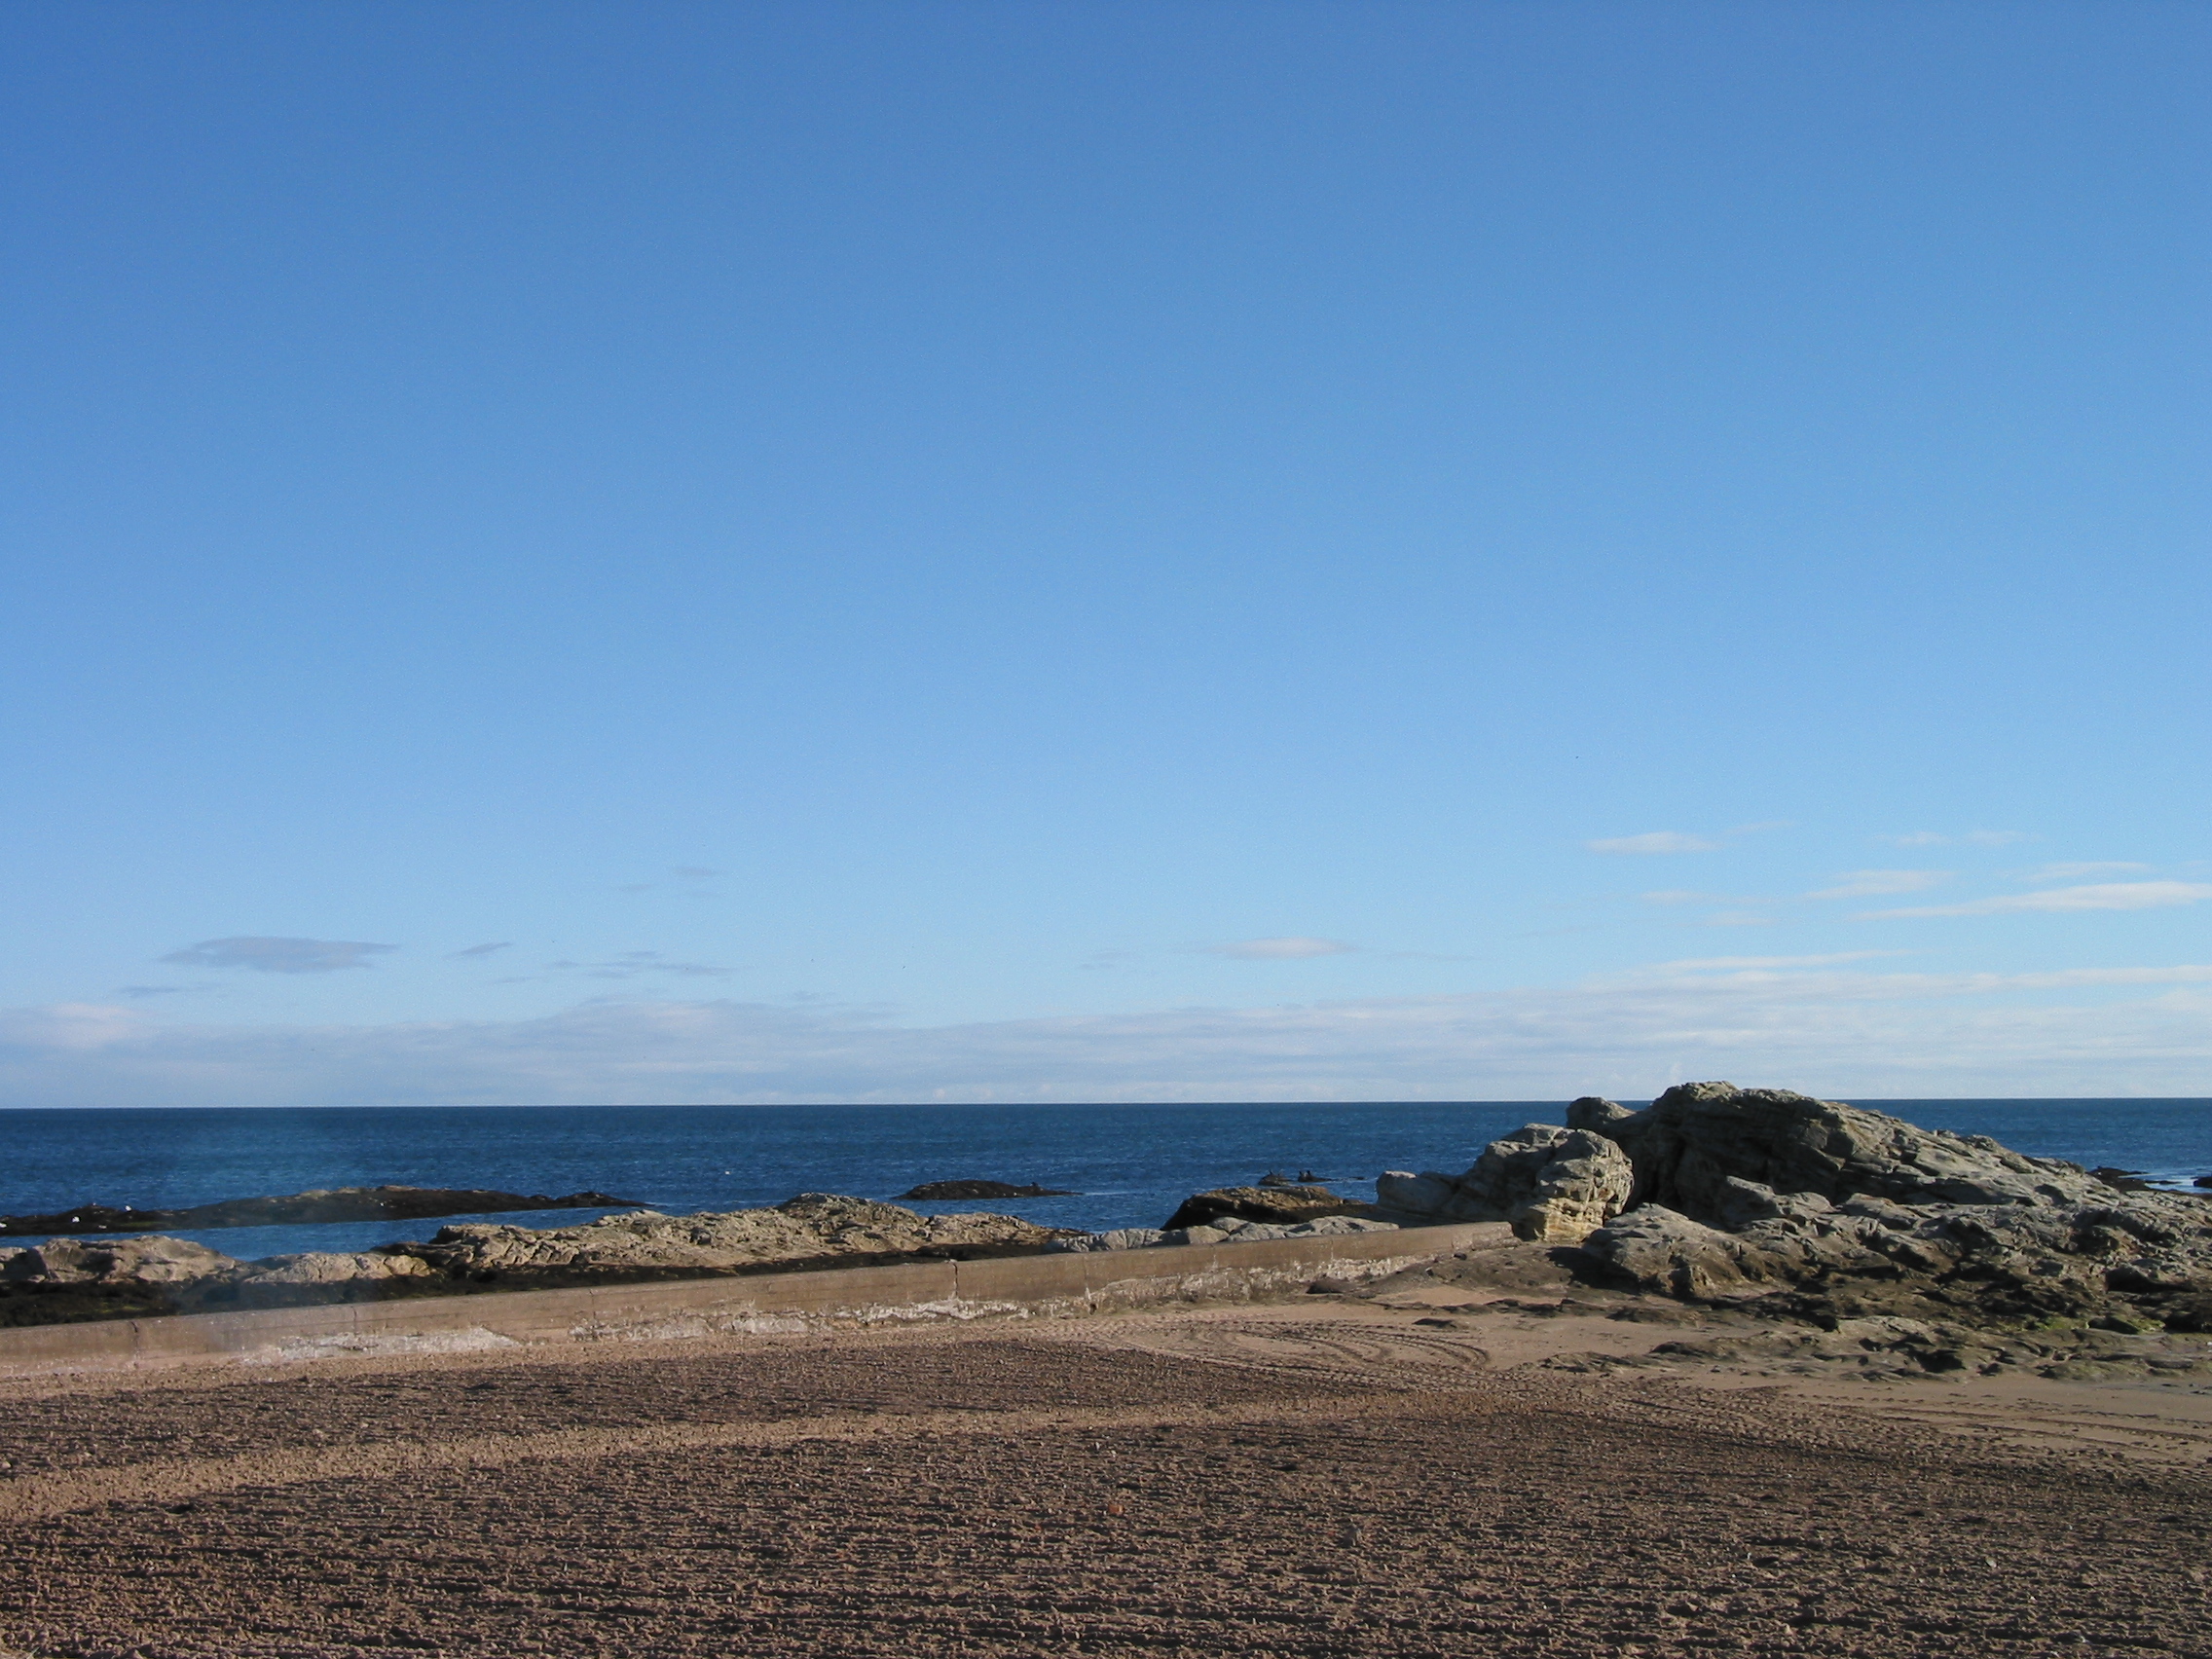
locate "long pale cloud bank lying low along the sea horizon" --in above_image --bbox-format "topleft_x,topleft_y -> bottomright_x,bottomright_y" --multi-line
17,958 -> 2212,1106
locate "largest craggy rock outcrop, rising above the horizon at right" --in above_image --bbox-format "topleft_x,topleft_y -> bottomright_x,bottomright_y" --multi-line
1581,1084 -> 2212,1329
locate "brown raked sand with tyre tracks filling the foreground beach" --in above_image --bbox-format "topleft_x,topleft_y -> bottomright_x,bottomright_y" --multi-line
0,1299 -> 2212,1659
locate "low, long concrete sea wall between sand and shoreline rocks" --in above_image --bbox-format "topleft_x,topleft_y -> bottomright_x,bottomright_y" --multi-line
0,1226 -> 1502,1378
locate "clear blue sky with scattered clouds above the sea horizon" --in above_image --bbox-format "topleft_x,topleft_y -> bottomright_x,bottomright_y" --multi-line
0,0 -> 2212,1104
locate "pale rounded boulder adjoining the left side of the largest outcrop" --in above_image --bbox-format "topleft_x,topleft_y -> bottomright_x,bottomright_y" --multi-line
1376,1124 -> 1633,1243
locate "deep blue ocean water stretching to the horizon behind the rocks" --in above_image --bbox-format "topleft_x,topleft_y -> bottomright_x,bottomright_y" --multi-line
0,1099 -> 2212,1259
